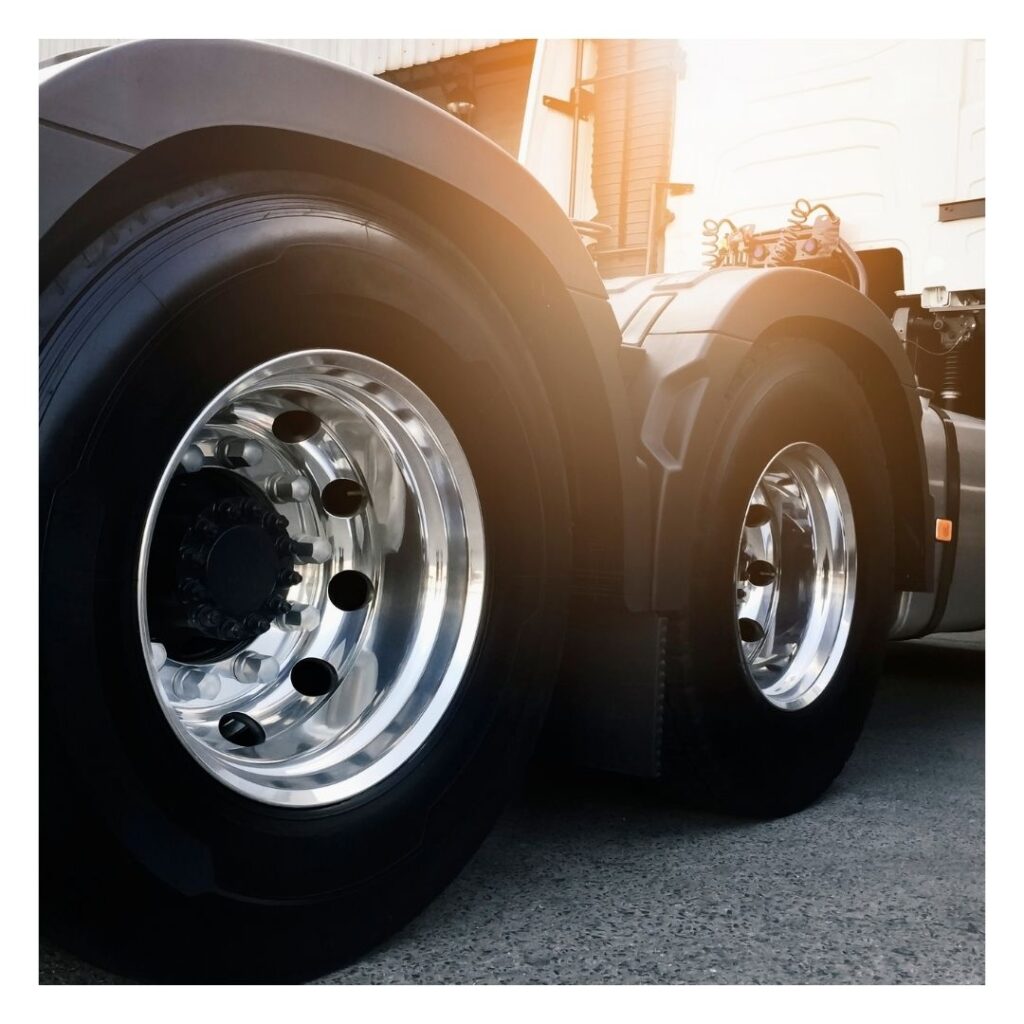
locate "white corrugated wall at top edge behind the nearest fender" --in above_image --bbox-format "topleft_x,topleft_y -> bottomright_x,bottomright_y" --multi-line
39,39 -> 511,75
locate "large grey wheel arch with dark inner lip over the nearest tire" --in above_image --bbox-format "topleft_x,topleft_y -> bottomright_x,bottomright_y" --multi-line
40,40 -> 645,598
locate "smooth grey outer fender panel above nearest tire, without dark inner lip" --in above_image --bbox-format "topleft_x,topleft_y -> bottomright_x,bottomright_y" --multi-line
39,39 -> 604,295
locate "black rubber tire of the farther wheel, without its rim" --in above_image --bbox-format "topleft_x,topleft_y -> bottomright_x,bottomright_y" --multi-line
665,339 -> 894,817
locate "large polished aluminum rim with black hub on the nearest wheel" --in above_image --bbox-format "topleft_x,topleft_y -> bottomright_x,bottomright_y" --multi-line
138,350 -> 485,806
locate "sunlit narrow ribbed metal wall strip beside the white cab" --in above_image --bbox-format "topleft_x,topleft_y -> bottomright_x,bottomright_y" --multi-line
591,39 -> 681,276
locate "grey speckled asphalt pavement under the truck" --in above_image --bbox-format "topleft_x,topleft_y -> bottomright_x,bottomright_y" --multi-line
40,634 -> 985,984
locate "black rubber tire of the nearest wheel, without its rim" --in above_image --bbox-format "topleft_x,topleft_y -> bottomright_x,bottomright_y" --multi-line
41,173 -> 569,981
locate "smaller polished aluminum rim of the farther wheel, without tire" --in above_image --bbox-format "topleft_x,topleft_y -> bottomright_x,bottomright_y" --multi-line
736,442 -> 857,711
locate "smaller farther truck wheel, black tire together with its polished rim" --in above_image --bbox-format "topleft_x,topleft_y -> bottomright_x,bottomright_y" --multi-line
666,339 -> 894,817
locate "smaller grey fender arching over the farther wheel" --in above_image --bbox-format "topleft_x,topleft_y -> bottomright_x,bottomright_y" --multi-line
632,268 -> 932,611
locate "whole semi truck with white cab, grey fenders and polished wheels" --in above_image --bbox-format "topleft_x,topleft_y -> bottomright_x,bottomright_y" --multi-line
39,40 -> 985,981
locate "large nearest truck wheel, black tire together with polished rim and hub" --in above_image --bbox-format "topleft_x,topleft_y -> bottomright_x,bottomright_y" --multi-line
40,173 -> 569,981
